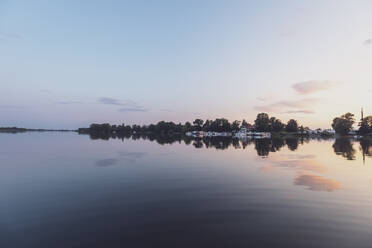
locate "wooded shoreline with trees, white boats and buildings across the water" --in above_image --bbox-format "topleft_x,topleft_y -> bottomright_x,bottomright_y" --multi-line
78,110 -> 372,139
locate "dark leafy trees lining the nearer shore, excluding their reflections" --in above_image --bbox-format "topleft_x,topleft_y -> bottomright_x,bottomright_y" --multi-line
78,113 -> 372,135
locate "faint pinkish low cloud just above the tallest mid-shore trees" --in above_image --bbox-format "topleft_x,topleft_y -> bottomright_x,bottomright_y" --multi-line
254,98 -> 320,114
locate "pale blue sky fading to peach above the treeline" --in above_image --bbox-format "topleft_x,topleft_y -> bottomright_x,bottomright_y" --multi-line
0,0 -> 372,129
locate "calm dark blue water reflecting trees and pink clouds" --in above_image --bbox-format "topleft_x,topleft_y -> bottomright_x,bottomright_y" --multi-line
0,133 -> 372,248
